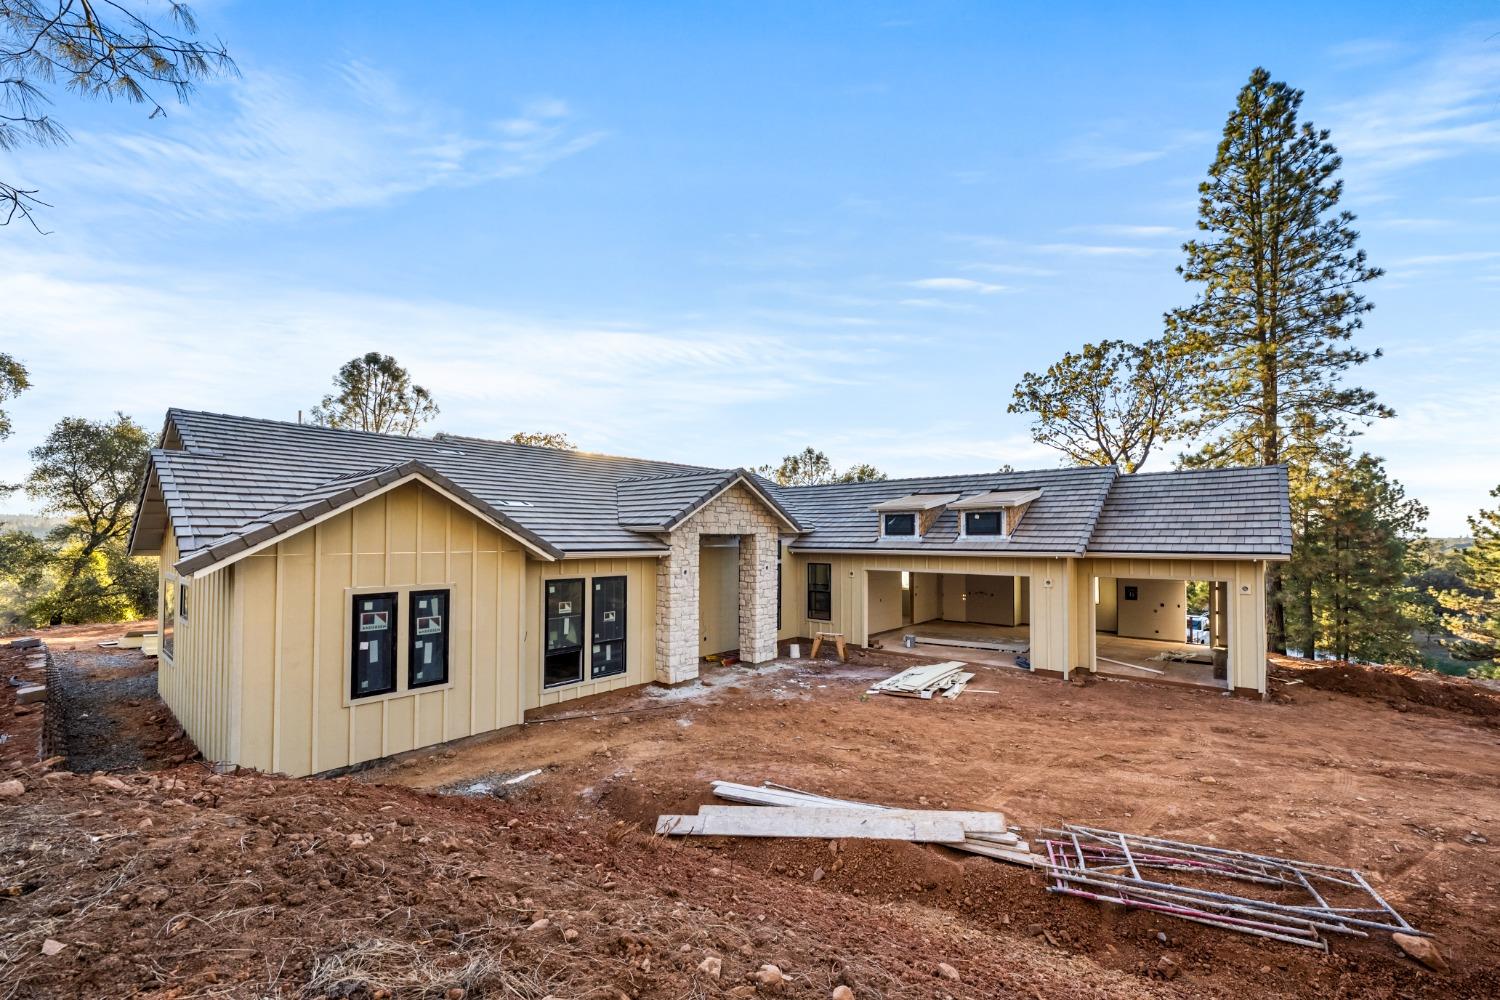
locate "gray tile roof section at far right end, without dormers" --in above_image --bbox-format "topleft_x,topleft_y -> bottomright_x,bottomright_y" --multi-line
1086,465 -> 1292,556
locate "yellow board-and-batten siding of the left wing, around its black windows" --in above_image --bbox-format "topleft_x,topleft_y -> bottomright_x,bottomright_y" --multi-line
158,483 -> 657,775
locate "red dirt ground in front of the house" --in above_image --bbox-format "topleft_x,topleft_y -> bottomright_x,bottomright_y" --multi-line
0,629 -> 1500,1000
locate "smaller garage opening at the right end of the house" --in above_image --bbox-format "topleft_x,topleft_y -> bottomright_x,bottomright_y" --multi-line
1094,576 -> 1230,690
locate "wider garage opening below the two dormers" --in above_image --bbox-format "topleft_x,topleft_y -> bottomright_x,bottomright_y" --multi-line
866,570 -> 1031,667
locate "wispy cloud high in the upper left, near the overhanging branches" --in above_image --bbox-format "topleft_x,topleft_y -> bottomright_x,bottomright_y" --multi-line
16,61 -> 605,219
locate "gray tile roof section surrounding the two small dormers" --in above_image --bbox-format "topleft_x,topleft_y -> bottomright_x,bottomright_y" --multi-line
774,466 -> 1116,555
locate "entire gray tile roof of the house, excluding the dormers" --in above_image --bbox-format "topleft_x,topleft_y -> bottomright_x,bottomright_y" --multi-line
131,409 -> 1292,571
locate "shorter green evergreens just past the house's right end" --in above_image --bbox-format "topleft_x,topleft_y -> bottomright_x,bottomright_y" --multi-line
1286,445 -> 1427,663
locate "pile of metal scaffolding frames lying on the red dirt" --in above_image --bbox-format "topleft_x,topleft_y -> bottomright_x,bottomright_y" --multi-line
1043,825 -> 1427,951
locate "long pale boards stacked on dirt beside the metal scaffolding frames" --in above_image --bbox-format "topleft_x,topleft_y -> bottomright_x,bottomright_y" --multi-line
657,781 -> 1044,867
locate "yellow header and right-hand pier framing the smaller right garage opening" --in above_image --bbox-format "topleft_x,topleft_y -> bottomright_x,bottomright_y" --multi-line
1077,559 -> 1266,694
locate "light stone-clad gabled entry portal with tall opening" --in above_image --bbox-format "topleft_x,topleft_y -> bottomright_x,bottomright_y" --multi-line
656,483 -> 782,684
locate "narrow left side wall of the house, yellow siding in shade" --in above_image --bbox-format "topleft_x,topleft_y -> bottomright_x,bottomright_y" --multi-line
156,525 -> 239,762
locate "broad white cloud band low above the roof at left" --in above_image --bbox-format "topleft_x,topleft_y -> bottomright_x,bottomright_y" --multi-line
0,249 -> 891,481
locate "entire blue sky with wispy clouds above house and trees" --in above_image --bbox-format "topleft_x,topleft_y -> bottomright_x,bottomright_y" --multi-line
0,0 -> 1500,534
